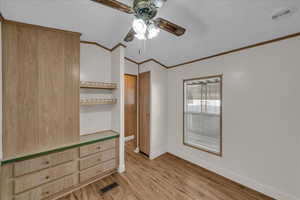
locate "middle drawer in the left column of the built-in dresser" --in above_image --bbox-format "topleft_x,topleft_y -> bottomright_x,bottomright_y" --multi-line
14,162 -> 77,194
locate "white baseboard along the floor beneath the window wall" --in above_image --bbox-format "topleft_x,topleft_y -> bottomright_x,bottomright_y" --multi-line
168,152 -> 299,200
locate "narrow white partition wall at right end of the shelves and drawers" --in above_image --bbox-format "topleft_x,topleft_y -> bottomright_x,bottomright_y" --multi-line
111,46 -> 125,173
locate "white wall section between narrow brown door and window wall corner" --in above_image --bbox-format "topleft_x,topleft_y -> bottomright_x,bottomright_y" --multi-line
140,61 -> 168,159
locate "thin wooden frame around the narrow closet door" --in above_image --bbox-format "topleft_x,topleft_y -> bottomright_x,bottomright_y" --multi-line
137,71 -> 152,158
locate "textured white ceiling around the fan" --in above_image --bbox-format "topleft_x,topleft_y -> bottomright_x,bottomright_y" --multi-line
0,0 -> 300,66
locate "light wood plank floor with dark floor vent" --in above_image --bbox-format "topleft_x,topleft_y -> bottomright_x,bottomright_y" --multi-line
60,143 -> 272,200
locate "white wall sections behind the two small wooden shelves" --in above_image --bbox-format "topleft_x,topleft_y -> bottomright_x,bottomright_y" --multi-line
80,43 -> 112,134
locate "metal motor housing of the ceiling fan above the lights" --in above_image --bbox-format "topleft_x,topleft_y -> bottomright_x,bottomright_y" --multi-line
133,0 -> 157,22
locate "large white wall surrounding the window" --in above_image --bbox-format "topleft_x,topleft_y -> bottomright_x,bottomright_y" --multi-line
168,37 -> 300,200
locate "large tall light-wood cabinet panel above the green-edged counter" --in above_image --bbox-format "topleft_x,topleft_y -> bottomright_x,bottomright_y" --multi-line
3,21 -> 80,158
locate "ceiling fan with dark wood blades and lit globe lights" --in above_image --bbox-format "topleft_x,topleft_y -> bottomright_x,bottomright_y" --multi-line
91,0 -> 185,42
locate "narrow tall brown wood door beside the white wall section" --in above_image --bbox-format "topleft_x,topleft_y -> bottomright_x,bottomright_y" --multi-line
139,72 -> 151,156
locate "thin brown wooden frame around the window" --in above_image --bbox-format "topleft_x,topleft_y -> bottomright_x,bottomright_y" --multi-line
182,74 -> 223,157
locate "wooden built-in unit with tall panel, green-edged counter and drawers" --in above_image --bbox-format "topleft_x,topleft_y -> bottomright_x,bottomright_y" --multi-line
0,20 -> 119,200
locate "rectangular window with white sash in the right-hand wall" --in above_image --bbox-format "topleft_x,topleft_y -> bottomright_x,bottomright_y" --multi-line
183,75 -> 222,156
